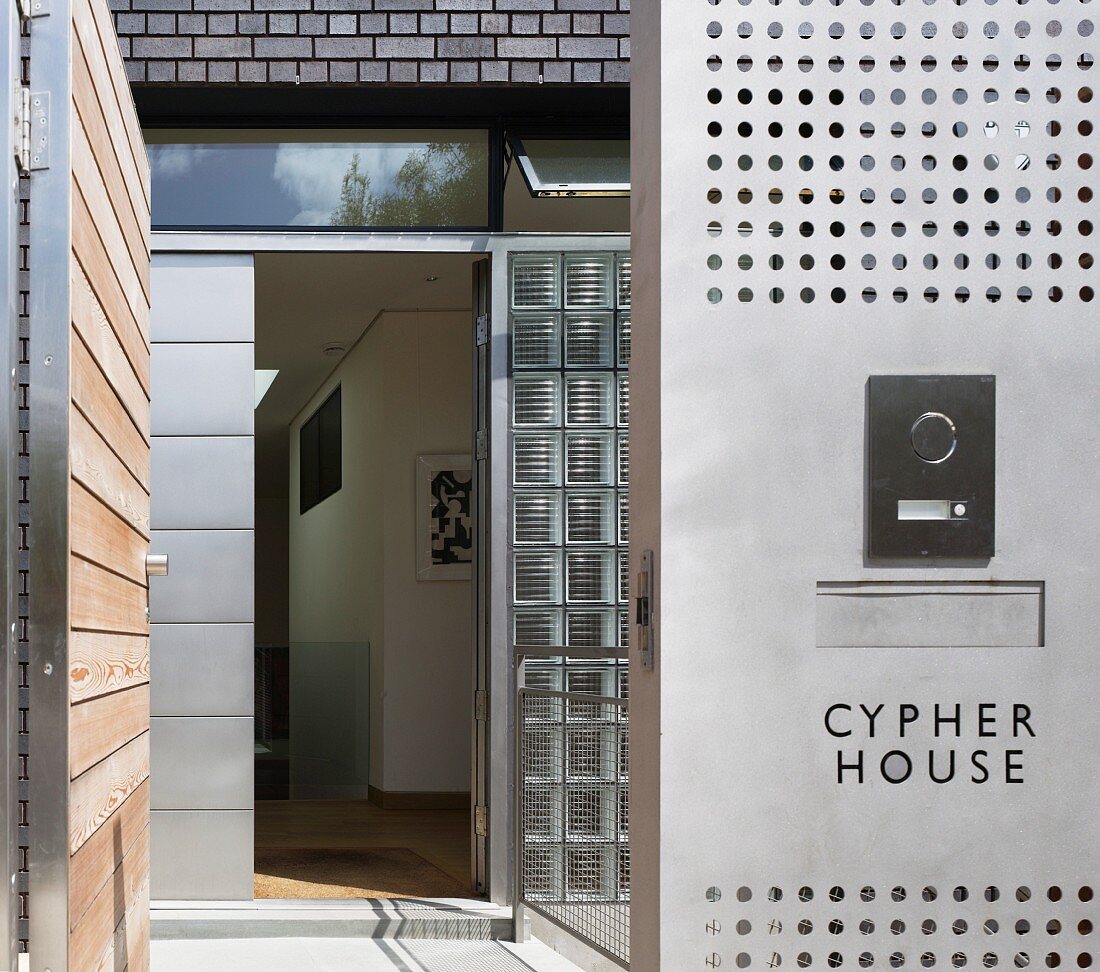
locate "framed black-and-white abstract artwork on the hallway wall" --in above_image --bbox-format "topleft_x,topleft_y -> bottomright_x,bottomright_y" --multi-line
416,455 -> 474,581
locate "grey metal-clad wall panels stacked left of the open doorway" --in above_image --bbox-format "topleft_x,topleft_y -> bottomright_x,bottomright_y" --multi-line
150,255 -> 254,899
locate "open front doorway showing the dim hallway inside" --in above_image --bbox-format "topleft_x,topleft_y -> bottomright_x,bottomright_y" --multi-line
255,253 -> 486,898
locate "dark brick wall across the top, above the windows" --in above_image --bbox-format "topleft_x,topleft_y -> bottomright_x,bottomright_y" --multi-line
111,0 -> 630,84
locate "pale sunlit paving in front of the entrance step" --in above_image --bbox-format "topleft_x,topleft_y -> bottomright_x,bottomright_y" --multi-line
152,938 -> 594,972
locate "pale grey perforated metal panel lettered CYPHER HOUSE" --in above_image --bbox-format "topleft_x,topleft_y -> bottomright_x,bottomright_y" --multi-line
631,0 -> 1100,970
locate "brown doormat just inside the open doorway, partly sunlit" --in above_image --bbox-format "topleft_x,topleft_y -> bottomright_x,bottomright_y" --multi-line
254,847 -> 471,898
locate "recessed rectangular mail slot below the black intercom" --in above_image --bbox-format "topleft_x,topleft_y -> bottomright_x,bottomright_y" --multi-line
815,581 -> 1044,648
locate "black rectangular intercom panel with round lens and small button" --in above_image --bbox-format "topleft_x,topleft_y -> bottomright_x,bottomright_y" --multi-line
868,375 -> 997,561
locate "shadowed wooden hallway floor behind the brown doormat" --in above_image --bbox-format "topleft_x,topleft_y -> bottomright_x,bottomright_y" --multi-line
255,799 -> 474,897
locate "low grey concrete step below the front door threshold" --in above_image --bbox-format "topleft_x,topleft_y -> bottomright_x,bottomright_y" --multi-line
151,898 -> 523,941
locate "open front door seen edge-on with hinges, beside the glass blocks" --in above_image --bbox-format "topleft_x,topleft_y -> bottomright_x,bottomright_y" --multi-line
470,257 -> 490,894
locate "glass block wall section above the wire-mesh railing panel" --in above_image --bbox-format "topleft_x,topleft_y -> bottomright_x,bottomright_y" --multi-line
509,246 -> 630,697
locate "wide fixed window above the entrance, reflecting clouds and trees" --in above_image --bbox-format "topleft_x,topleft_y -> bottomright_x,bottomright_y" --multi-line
144,129 -> 490,230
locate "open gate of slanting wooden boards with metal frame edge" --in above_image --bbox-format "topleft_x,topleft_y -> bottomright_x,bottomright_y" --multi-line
26,0 -> 150,972
